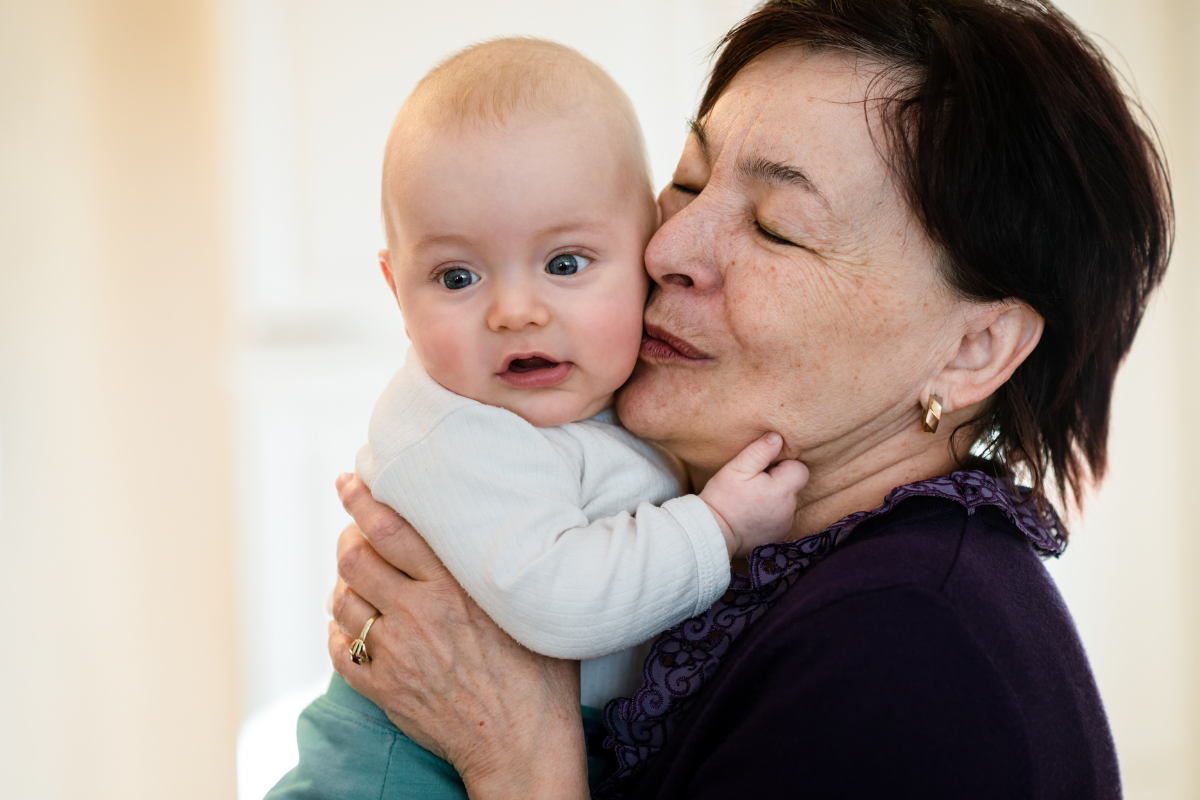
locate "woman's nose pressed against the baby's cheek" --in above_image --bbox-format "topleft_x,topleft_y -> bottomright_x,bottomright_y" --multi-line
646,194 -> 721,294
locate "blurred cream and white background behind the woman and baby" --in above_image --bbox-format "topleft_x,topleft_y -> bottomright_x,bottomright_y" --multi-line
0,0 -> 1200,800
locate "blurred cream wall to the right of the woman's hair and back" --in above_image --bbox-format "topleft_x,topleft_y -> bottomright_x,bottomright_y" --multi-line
1051,0 -> 1200,800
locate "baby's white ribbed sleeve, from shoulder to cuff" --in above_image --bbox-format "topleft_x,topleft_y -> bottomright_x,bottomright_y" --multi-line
359,404 -> 730,658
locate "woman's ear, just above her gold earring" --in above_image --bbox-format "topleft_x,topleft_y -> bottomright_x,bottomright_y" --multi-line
926,300 -> 1045,413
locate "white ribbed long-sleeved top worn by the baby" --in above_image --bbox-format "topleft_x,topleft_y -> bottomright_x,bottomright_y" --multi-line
358,354 -> 730,706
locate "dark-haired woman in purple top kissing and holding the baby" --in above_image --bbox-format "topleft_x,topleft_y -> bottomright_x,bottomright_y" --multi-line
330,0 -> 1171,798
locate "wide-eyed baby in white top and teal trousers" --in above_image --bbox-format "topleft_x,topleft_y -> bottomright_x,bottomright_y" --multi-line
269,38 -> 806,798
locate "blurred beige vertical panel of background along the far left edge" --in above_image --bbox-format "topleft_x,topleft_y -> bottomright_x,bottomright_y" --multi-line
0,0 -> 238,800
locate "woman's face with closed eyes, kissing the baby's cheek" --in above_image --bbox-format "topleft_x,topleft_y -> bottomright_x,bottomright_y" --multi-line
618,48 -> 960,473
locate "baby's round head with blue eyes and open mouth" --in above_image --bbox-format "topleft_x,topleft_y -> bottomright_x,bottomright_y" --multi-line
379,38 -> 656,426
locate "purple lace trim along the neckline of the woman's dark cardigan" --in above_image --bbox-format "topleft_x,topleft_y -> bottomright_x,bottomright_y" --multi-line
594,470 -> 1067,798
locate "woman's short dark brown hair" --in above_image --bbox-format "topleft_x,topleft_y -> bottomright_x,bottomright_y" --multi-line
700,0 -> 1172,510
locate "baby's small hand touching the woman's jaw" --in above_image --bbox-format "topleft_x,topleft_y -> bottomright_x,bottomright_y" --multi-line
700,433 -> 809,558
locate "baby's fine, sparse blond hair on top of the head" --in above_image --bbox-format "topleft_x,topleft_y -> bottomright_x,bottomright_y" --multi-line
383,36 -> 654,243
